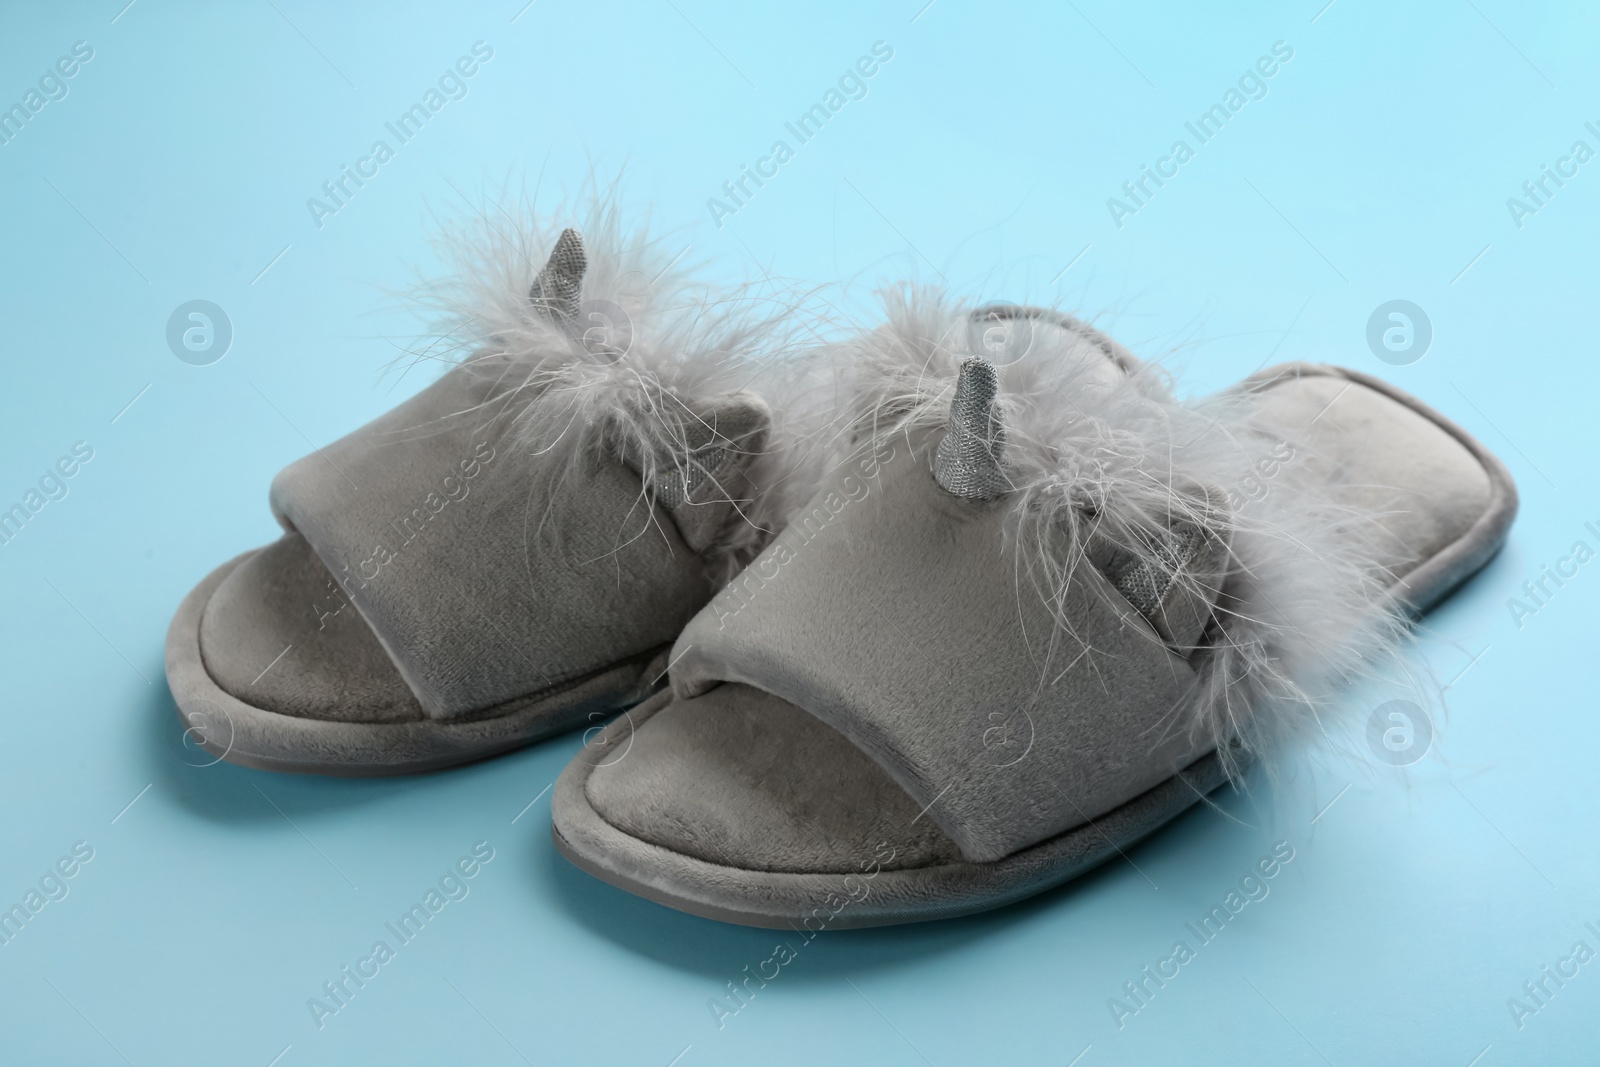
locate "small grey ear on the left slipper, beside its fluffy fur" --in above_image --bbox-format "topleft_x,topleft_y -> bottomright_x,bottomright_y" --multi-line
650,390 -> 773,552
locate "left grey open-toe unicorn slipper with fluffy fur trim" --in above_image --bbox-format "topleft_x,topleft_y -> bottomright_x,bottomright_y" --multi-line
166,210 -> 825,776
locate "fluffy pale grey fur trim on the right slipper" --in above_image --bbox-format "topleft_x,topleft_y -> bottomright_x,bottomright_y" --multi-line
840,288 -> 1408,776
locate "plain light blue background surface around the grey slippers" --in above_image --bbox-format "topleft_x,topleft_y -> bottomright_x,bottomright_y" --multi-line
0,0 -> 1600,1067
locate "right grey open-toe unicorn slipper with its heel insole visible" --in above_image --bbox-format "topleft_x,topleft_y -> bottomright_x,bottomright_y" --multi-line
552,289 -> 1517,929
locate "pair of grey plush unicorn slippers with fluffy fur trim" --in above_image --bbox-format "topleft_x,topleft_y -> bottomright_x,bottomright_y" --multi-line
166,207 -> 1517,928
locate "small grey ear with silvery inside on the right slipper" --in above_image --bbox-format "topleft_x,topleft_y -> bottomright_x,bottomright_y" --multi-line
1090,486 -> 1232,654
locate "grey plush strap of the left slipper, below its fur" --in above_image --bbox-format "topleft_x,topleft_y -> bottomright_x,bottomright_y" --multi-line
272,368 -> 710,718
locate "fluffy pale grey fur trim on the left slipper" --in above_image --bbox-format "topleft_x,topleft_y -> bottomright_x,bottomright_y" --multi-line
416,190 -> 834,584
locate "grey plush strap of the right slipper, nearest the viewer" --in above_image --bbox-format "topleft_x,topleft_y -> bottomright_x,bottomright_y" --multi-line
672,432 -> 1202,861
